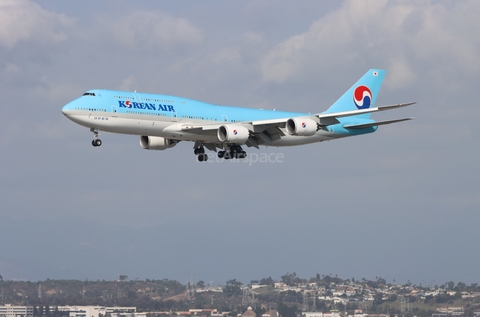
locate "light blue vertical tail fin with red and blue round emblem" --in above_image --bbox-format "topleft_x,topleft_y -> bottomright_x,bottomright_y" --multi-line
324,69 -> 385,118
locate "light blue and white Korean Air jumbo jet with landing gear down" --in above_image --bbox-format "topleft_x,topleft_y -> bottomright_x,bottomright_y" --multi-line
62,69 -> 415,162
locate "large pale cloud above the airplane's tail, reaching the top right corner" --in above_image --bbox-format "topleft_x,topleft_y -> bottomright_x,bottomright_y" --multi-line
262,0 -> 480,86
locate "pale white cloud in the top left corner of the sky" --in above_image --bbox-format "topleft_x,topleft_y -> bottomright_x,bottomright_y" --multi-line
0,0 -> 73,48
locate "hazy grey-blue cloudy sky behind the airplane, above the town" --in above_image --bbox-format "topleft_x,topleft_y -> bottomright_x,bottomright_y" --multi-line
0,0 -> 480,285
